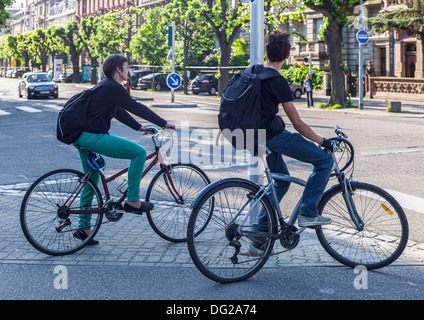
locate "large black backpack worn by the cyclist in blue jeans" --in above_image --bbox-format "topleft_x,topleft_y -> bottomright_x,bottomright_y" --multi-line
218,67 -> 278,156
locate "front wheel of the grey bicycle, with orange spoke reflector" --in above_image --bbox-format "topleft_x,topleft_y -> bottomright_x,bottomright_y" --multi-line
316,183 -> 409,270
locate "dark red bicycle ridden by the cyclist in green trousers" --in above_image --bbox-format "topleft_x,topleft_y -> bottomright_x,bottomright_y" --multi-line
20,127 -> 210,255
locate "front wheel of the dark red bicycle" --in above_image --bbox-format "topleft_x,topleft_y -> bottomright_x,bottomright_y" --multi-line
146,163 -> 210,242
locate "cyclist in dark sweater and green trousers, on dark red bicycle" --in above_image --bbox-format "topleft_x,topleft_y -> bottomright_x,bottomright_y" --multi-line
73,54 -> 175,245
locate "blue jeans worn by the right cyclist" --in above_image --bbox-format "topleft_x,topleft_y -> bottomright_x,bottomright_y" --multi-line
254,130 -> 333,231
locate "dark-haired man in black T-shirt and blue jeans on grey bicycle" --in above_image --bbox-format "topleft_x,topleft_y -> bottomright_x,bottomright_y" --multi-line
252,31 -> 337,248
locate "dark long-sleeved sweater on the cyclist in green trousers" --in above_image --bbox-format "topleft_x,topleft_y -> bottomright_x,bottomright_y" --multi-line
84,78 -> 166,133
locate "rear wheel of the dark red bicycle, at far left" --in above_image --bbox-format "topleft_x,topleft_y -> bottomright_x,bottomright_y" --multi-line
20,169 -> 103,256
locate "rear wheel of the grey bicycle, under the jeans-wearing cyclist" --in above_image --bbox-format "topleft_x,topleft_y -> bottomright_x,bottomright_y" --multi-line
187,179 -> 277,283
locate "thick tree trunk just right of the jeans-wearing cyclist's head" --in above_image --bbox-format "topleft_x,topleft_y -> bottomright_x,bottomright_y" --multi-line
325,20 -> 346,108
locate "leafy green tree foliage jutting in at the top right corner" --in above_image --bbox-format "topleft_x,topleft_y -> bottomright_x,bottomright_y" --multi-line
369,0 -> 424,77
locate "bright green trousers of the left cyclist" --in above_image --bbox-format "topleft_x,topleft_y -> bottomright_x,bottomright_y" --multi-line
74,132 -> 147,229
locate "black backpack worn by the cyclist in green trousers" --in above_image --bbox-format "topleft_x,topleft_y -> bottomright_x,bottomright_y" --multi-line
56,85 -> 100,144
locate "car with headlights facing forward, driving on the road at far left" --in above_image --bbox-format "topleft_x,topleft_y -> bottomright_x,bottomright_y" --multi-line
18,72 -> 59,99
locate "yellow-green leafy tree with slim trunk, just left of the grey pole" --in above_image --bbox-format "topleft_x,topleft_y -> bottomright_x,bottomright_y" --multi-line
199,0 -> 250,95
